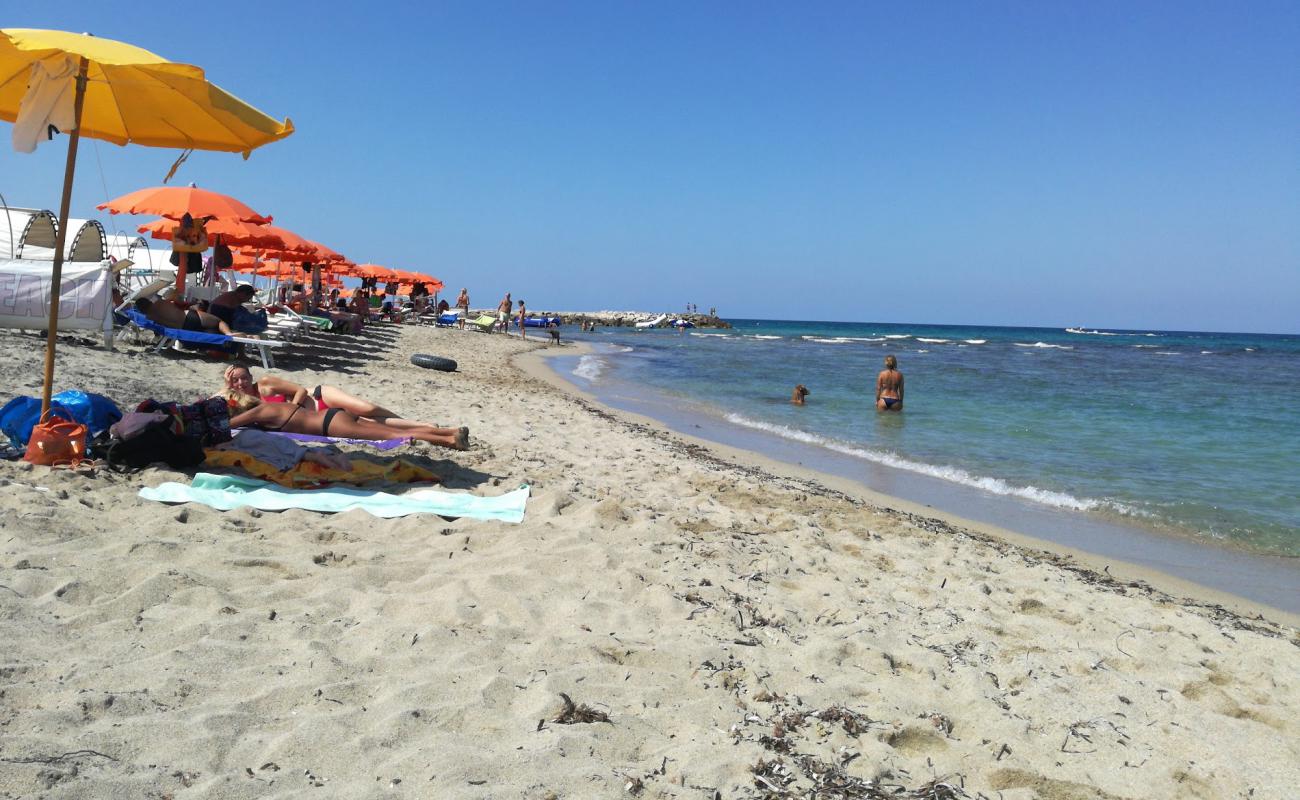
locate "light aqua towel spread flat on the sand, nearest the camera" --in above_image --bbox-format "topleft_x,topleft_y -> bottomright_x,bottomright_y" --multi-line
140,472 -> 528,522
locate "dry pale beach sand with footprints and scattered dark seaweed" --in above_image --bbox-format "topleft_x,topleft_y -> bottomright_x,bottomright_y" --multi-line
0,327 -> 1300,800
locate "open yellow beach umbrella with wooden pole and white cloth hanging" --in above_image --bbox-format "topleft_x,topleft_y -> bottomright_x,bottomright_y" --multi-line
0,29 -> 294,412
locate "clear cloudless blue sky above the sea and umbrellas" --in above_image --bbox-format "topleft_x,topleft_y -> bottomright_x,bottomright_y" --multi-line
0,0 -> 1300,333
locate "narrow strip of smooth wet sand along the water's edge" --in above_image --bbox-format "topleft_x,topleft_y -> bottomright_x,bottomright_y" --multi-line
514,341 -> 1300,628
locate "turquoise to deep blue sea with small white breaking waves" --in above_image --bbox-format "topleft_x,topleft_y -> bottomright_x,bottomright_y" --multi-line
567,320 -> 1300,557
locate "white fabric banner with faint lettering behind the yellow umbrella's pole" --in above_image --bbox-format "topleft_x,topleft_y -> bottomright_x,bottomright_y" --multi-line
0,260 -> 113,333
